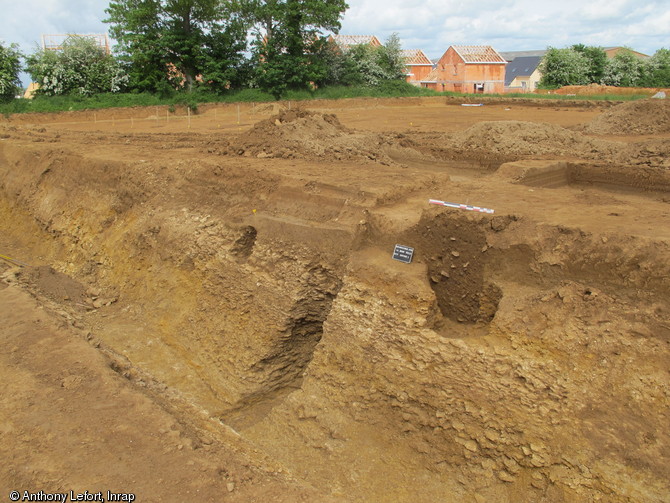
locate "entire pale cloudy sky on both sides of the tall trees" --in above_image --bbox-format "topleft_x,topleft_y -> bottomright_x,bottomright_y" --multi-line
0,0 -> 670,83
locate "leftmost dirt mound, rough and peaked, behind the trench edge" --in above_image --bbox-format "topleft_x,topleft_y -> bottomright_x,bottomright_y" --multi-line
227,110 -> 419,164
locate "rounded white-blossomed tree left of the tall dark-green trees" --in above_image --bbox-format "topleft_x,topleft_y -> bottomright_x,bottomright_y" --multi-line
27,35 -> 128,96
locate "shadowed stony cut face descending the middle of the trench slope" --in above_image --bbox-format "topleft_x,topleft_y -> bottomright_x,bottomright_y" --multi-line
223,266 -> 341,430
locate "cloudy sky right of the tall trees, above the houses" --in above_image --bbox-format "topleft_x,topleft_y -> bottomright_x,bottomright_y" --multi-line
342,0 -> 670,57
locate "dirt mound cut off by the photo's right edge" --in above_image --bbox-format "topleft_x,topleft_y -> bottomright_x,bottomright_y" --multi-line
584,99 -> 670,135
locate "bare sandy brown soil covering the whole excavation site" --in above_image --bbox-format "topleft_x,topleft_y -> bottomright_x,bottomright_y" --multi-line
0,98 -> 670,503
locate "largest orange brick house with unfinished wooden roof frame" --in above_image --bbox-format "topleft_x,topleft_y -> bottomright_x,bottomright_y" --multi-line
421,45 -> 507,94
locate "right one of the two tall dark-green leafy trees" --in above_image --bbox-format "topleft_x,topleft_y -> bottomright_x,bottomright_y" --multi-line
245,0 -> 348,99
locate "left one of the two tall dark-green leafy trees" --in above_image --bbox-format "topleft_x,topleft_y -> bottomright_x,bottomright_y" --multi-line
105,0 -> 246,92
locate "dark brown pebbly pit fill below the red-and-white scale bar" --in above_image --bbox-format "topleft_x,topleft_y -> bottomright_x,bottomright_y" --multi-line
418,213 -> 502,323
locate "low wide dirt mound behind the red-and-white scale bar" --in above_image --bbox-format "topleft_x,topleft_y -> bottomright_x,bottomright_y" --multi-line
447,121 -> 620,158
